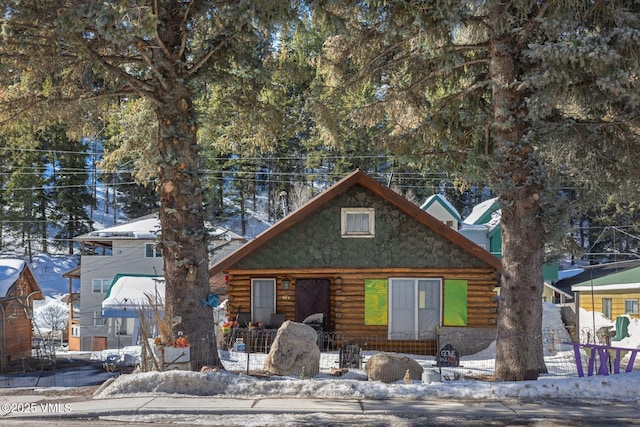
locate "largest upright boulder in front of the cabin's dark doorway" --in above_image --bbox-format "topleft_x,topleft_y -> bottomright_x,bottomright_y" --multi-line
264,320 -> 320,377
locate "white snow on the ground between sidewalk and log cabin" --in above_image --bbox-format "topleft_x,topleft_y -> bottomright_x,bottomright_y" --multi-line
85,304 -> 640,401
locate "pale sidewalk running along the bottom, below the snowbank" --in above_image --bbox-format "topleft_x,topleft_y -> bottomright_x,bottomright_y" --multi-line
0,394 -> 640,424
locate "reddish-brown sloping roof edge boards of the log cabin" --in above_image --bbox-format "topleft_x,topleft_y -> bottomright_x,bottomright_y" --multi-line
209,170 -> 502,277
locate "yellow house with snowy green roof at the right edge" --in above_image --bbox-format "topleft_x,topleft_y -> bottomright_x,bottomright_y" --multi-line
571,267 -> 640,320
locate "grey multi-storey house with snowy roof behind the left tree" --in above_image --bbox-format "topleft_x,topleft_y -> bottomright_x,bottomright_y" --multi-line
70,214 -> 245,351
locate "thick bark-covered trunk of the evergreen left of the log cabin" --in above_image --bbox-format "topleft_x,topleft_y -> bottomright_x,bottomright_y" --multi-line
157,83 -> 221,370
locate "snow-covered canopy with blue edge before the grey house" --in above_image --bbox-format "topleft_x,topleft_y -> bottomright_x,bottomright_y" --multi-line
102,274 -> 165,317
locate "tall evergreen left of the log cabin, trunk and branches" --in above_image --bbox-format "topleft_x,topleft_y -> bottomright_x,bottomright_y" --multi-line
0,0 -> 299,368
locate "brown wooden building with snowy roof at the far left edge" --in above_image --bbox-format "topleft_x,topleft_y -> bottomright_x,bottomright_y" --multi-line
0,259 -> 44,372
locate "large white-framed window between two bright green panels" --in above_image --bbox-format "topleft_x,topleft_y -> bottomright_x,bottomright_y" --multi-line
388,278 -> 442,340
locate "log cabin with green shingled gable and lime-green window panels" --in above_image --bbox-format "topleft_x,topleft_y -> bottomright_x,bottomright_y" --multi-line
209,171 -> 501,353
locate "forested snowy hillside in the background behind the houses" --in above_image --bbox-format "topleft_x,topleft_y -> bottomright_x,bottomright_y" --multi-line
0,127 -> 640,263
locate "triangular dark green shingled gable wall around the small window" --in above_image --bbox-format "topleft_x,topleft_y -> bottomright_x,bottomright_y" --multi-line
234,184 -> 487,269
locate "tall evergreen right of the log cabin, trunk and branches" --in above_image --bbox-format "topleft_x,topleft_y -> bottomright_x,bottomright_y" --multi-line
317,0 -> 640,380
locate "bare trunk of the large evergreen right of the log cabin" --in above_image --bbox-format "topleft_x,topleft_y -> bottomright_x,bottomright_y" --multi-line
491,25 -> 546,381
